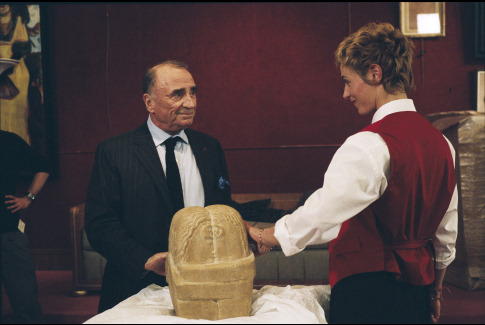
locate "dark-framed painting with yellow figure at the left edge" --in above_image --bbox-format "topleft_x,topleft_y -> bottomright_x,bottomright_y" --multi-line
0,2 -> 58,176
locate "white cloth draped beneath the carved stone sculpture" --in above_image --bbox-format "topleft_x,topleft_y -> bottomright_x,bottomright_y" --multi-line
85,284 -> 330,324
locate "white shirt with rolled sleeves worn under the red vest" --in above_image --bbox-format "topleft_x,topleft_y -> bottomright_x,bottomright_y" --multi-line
274,99 -> 458,269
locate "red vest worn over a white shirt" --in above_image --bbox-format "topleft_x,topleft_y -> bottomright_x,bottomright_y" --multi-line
329,112 -> 456,287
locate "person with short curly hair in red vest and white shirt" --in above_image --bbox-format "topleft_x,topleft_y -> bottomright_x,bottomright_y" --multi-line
246,23 -> 458,324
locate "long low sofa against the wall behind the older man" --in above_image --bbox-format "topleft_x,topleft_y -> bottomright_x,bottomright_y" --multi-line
69,193 -> 328,296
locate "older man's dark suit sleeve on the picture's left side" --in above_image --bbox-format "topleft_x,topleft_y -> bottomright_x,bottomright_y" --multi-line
85,144 -> 154,279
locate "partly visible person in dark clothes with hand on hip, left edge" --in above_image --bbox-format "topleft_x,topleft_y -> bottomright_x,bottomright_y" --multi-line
0,131 -> 49,324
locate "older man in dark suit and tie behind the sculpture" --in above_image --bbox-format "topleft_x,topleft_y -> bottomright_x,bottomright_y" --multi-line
85,61 -> 236,312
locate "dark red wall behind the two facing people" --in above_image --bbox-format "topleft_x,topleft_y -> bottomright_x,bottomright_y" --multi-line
25,2 -> 483,268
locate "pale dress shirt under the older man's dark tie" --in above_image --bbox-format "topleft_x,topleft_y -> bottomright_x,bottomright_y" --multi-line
147,117 -> 205,207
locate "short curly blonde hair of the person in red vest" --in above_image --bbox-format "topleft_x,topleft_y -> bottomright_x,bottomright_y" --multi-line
335,23 -> 414,94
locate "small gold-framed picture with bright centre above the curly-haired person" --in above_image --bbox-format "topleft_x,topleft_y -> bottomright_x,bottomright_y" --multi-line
399,2 -> 445,38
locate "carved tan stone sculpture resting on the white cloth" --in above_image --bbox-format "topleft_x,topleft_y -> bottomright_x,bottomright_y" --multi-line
166,205 -> 255,320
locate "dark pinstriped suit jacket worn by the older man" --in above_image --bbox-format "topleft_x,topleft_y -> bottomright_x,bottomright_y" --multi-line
85,123 -> 231,312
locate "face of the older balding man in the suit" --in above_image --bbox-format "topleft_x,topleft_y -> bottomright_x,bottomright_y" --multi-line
143,65 -> 197,135
